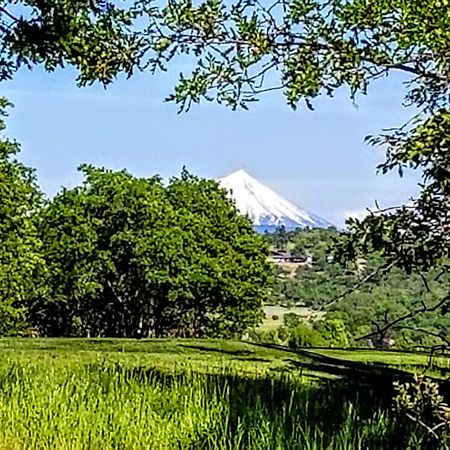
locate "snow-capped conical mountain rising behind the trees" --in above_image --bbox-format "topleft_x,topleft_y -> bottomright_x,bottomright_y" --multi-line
217,169 -> 333,232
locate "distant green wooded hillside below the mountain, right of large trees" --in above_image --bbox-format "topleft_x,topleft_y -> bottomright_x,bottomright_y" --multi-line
265,229 -> 450,348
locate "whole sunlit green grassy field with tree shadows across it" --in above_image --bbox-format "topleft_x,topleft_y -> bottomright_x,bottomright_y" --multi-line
0,339 -> 446,449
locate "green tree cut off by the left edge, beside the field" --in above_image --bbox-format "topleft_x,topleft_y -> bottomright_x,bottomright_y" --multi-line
0,99 -> 44,336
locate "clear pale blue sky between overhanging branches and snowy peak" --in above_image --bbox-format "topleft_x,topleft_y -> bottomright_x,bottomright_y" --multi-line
2,64 -> 418,225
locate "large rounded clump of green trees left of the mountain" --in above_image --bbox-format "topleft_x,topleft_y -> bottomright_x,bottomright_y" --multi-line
35,166 -> 270,337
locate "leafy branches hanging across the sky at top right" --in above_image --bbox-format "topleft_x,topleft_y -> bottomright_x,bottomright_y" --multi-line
134,0 -> 450,110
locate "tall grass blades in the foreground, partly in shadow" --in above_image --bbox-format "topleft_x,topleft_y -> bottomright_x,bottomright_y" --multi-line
0,360 -> 432,450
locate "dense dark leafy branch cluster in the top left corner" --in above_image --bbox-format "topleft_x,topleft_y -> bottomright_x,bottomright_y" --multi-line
0,0 -> 142,84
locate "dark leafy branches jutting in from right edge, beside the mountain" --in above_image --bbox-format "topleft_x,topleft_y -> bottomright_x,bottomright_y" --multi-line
340,108 -> 450,284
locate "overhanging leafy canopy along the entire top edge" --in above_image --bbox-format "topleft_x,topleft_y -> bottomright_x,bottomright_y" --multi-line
4,0 -> 450,109
